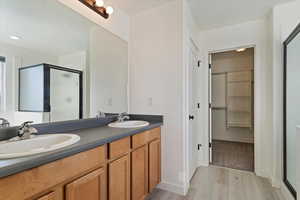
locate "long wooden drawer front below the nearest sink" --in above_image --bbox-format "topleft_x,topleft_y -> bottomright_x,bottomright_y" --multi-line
0,146 -> 106,200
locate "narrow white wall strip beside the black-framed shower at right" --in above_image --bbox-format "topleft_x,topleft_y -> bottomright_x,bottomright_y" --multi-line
271,0 -> 300,198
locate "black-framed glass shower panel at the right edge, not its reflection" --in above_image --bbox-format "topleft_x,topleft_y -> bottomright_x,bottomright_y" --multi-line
284,24 -> 300,198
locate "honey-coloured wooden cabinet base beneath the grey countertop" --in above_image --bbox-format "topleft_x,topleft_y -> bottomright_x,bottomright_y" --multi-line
0,128 -> 161,200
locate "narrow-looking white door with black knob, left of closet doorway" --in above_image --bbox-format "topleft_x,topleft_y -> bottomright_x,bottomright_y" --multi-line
189,45 -> 200,179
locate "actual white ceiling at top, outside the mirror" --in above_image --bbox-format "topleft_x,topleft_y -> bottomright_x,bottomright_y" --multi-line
108,0 -> 291,29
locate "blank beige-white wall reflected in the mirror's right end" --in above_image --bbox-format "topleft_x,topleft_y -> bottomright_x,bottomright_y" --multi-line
89,27 -> 128,117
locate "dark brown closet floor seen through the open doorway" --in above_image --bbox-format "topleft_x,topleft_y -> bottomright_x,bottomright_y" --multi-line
212,140 -> 254,172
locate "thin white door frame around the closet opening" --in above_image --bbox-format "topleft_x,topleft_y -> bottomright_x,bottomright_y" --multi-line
207,44 -> 261,174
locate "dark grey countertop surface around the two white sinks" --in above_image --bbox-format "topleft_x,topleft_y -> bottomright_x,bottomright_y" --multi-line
0,115 -> 163,178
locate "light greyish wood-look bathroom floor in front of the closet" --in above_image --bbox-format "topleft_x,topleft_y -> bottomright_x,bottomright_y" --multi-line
147,166 -> 284,200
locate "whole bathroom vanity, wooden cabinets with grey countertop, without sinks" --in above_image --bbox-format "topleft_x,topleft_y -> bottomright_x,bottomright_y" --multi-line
0,123 -> 161,200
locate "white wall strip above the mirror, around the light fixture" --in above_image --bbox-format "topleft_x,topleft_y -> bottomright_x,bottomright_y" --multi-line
57,0 -> 130,41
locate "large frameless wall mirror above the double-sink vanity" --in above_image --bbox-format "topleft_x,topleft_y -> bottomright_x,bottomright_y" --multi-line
0,0 -> 128,126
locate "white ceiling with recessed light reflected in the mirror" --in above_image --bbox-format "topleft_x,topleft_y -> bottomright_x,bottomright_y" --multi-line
0,0 -> 95,56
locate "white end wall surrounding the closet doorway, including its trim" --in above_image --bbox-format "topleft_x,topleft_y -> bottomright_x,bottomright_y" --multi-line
200,20 -> 272,180
